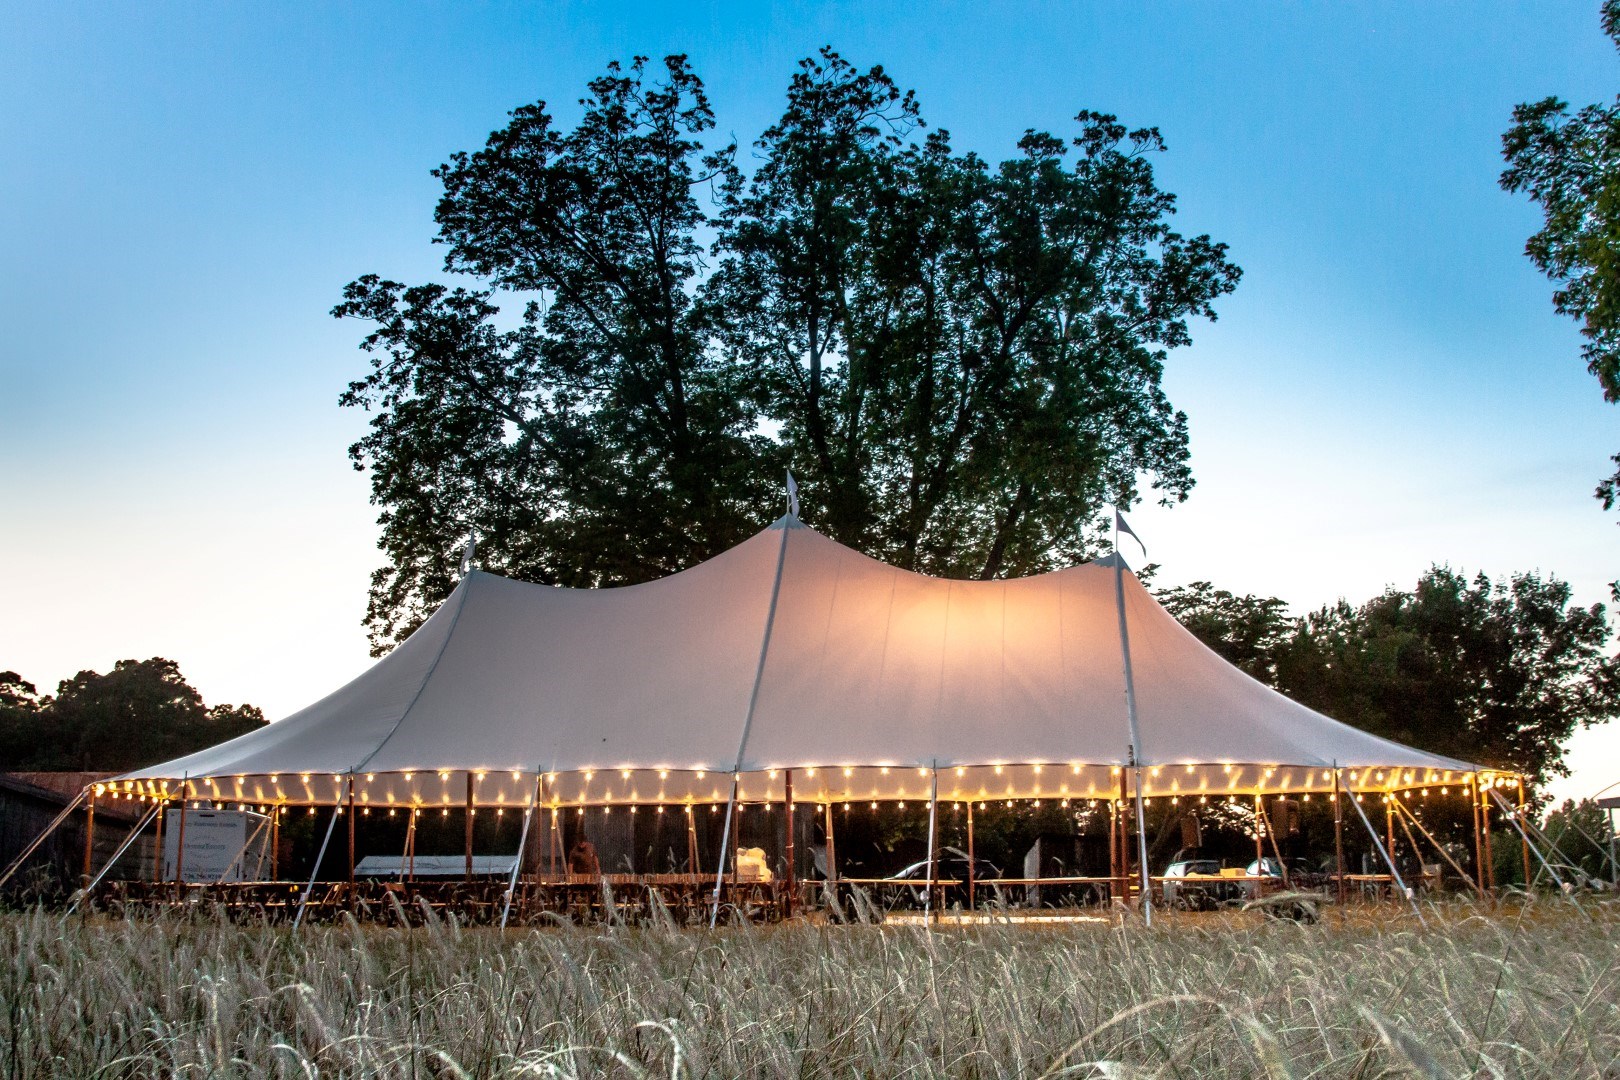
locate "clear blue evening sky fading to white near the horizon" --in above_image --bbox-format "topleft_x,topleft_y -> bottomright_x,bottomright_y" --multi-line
0,3 -> 1620,803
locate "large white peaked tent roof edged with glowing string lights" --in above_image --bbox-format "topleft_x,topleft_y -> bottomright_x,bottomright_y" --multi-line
110,517 -> 1476,806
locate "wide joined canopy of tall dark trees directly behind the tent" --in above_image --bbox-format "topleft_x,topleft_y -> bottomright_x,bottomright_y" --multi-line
334,50 -> 1239,653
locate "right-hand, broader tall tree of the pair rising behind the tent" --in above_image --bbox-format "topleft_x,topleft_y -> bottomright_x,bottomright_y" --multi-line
710,50 -> 1238,578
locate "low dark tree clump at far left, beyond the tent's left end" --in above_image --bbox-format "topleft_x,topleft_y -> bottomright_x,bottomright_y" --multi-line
0,656 -> 266,772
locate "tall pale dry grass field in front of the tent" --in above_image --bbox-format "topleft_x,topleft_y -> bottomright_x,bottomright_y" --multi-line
0,900 -> 1620,1078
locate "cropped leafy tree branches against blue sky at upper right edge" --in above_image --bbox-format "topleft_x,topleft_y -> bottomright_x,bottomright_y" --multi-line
1502,0 -> 1620,527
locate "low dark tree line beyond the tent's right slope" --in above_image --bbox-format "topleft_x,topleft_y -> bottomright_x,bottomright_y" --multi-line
1160,567 -> 1620,782
